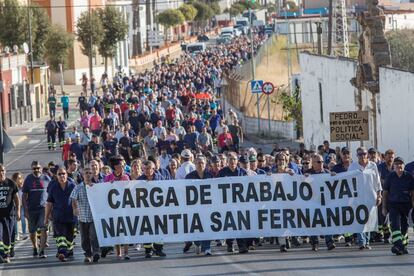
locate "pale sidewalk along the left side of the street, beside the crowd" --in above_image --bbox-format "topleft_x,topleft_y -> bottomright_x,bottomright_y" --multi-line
6,85 -> 82,147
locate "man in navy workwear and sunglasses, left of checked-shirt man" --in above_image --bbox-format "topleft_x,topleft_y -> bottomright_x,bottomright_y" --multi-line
44,167 -> 76,262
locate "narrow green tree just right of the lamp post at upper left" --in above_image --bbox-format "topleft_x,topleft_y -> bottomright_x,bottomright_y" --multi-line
31,7 -> 51,61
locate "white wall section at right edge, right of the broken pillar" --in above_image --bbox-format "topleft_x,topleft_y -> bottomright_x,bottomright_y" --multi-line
377,68 -> 414,162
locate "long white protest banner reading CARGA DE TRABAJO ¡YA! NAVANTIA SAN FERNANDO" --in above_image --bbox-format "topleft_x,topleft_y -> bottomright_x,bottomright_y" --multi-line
87,171 -> 377,246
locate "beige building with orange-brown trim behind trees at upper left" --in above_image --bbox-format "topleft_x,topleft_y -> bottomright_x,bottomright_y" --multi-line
33,0 -> 112,84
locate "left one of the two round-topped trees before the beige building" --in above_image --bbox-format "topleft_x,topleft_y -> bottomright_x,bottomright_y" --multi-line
76,10 -> 104,76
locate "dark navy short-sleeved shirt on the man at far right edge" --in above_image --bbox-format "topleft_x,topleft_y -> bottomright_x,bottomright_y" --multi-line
384,172 -> 414,204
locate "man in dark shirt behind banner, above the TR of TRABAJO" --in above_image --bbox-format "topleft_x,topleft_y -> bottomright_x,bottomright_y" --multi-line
218,152 -> 249,254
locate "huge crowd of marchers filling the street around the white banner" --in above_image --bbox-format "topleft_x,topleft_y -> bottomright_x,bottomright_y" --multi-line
0,31 -> 414,263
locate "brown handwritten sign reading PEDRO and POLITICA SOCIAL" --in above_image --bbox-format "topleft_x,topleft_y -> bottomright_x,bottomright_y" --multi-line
329,111 -> 369,142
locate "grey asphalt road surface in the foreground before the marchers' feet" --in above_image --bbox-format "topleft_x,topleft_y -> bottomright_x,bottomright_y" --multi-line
1,236 -> 414,276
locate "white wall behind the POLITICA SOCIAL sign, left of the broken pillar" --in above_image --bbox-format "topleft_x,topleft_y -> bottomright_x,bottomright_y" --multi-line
300,53 -> 373,152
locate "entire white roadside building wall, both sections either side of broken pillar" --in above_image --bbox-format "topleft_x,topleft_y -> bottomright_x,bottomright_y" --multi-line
300,53 -> 414,161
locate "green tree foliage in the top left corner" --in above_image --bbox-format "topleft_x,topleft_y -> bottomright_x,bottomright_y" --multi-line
0,0 -> 29,48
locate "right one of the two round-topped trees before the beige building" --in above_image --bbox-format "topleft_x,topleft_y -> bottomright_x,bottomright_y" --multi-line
98,6 -> 128,72
